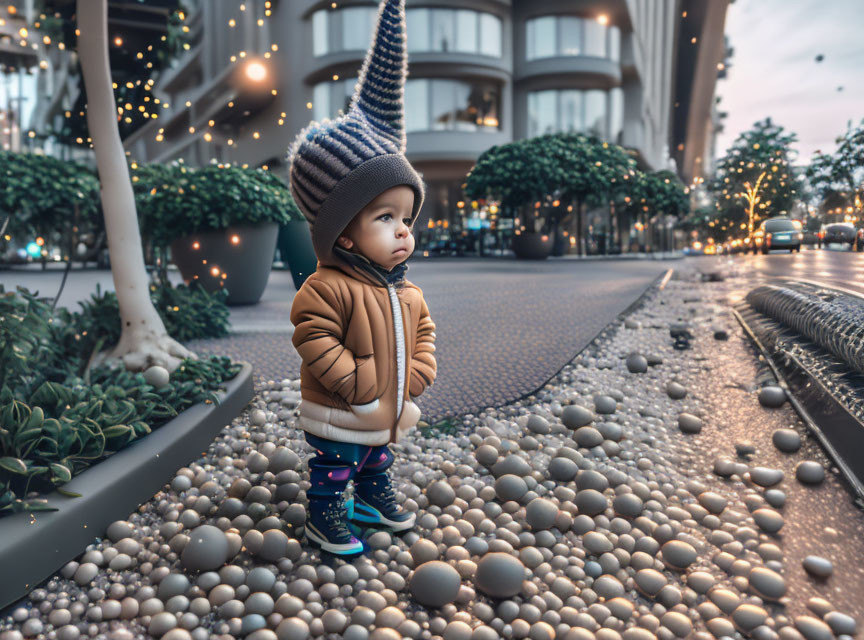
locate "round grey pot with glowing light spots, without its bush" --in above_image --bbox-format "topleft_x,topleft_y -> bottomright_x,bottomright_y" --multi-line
171,222 -> 279,305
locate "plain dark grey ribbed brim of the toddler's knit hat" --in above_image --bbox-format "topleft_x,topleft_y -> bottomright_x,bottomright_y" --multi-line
312,153 -> 424,266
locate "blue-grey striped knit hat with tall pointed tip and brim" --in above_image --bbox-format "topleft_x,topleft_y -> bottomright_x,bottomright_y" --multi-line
289,0 -> 424,266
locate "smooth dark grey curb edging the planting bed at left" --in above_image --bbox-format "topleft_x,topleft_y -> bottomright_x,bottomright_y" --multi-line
0,362 -> 254,609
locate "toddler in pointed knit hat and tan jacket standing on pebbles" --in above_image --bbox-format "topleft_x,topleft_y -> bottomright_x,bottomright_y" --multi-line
289,0 -> 436,555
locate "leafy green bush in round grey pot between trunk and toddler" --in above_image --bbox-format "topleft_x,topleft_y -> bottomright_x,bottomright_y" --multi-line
132,163 -> 303,305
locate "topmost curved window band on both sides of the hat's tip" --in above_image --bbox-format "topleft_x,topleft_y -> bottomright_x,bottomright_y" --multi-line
312,6 -> 503,57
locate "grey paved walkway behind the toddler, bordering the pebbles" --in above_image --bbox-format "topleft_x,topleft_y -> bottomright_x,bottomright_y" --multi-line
0,258 -> 681,423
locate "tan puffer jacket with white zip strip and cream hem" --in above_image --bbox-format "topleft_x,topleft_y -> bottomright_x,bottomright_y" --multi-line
291,263 -> 437,445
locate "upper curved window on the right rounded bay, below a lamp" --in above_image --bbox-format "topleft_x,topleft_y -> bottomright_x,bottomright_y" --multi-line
525,16 -> 621,61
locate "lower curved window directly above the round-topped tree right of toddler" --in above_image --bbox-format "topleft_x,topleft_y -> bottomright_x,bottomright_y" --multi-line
528,88 -> 624,142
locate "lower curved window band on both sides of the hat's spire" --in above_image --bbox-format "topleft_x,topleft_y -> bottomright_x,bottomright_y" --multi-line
312,78 -> 501,132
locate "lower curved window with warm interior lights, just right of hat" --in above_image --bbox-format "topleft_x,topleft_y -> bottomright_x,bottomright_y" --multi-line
405,78 -> 501,132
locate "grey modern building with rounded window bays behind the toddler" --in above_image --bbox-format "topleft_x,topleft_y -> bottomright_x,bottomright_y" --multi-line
33,0 -> 728,252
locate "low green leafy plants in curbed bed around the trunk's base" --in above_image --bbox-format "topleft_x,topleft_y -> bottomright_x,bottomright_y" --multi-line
0,285 -> 240,516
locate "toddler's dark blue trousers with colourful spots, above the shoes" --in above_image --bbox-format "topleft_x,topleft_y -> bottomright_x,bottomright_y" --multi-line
306,432 -> 394,499
